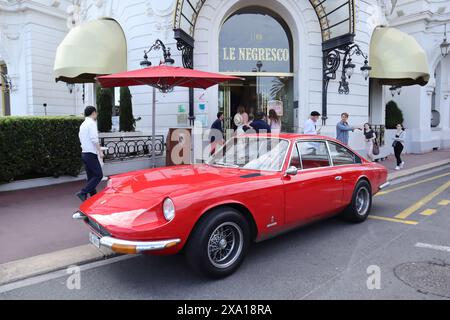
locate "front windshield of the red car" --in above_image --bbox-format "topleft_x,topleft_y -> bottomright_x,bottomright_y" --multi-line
208,137 -> 289,171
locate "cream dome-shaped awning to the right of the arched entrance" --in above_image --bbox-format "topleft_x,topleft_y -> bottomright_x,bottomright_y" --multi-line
370,27 -> 430,86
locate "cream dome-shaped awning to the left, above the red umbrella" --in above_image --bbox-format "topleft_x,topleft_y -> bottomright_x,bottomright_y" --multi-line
54,19 -> 127,83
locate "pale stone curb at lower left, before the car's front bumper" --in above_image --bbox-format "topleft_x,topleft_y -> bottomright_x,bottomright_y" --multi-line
0,244 -> 116,286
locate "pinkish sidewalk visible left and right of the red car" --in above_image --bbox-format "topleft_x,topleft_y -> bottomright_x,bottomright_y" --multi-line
0,150 -> 450,283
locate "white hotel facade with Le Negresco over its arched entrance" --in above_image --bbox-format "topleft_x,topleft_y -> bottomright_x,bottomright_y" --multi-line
0,0 -> 450,158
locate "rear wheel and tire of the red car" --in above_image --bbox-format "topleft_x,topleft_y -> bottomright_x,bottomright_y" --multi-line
342,180 -> 372,223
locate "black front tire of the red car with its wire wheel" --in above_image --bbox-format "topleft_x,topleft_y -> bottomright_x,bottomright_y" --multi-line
186,207 -> 250,279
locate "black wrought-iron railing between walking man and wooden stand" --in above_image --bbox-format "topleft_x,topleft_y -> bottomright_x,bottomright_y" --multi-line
100,136 -> 166,163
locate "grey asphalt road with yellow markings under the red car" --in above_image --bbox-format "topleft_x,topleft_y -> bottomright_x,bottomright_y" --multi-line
0,169 -> 450,300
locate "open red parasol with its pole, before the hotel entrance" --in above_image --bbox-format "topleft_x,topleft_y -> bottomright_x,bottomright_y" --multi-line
97,65 -> 242,166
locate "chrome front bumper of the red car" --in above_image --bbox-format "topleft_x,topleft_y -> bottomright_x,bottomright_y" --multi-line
72,212 -> 181,254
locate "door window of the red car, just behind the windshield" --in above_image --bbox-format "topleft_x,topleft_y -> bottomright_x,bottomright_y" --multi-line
297,141 -> 330,170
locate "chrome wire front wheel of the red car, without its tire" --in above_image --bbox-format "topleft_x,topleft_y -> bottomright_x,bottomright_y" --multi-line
208,222 -> 243,269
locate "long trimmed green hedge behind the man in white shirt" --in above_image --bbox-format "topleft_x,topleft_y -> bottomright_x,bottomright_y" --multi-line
0,117 -> 83,182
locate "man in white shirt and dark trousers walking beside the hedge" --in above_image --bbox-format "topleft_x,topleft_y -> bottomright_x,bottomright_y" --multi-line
76,106 -> 104,202
